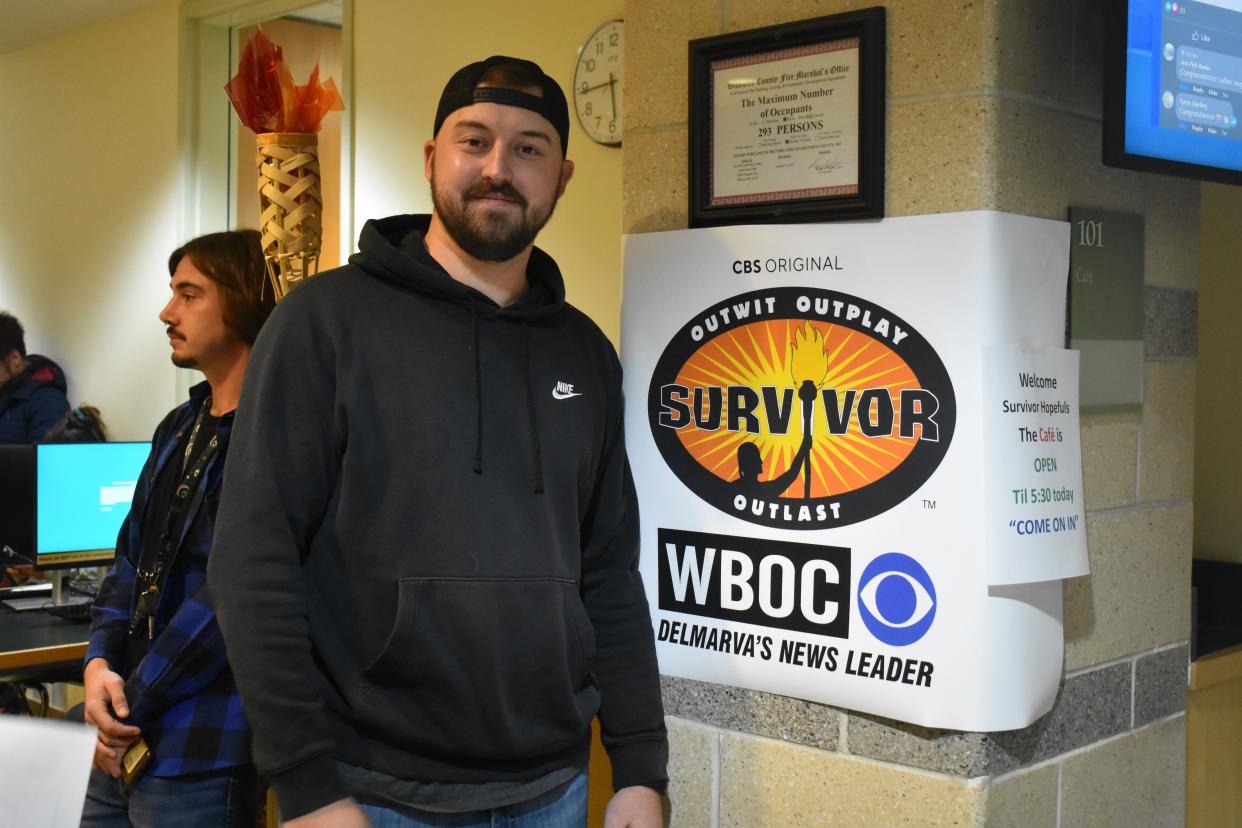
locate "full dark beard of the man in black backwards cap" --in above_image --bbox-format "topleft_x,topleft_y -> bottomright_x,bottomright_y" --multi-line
431,168 -> 556,262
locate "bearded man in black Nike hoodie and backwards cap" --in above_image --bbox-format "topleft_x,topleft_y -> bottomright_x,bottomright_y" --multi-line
209,57 -> 667,828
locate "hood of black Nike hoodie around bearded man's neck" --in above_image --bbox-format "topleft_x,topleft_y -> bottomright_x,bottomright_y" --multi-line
349,215 -> 565,322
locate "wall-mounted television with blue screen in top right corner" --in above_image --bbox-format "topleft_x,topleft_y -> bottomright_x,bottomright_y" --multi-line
1104,0 -> 1242,185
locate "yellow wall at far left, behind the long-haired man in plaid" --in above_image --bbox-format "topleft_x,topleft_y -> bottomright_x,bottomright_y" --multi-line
0,0 -> 180,439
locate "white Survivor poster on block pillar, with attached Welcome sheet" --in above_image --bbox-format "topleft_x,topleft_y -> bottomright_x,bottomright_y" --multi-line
622,212 -> 1087,731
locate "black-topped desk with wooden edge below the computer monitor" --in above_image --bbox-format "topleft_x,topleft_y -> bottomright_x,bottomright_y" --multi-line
0,608 -> 91,682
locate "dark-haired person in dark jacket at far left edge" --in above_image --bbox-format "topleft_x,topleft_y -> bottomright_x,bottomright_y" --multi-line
0,312 -> 70,444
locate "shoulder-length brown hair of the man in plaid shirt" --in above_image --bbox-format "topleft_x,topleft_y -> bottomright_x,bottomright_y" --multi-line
168,230 -> 276,345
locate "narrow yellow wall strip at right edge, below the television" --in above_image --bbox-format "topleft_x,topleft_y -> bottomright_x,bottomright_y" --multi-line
1195,184 -> 1242,564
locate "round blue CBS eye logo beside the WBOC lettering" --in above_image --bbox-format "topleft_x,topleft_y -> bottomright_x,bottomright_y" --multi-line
858,552 -> 936,647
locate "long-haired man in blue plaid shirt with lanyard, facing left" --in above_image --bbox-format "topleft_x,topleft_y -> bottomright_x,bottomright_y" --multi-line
82,231 -> 273,826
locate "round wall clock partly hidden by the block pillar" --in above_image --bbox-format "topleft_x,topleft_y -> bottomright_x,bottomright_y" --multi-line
574,20 -> 625,146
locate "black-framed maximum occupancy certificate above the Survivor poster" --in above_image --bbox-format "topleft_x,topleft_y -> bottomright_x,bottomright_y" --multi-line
691,9 -> 884,226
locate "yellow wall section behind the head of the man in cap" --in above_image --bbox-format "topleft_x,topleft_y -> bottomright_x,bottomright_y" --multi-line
354,0 -> 622,343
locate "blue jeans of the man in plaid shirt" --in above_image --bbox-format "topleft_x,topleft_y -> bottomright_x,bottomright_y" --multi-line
82,766 -> 258,828
